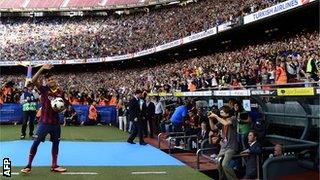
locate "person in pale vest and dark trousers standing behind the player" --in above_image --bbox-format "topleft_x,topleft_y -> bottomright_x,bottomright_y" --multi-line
20,83 -> 37,139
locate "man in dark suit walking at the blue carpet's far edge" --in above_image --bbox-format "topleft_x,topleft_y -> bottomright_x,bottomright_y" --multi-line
127,90 -> 147,145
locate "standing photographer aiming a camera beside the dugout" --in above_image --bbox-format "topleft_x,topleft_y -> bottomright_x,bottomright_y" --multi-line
208,106 -> 238,180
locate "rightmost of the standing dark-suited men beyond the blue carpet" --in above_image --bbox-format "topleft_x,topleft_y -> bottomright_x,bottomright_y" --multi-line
143,96 -> 156,138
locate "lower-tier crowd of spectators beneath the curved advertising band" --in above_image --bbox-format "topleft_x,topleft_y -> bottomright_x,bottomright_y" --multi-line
0,31 -> 319,104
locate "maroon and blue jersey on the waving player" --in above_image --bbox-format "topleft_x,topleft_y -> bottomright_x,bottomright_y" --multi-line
39,86 -> 66,124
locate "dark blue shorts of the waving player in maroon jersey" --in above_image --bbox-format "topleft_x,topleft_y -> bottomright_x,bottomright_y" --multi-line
35,123 -> 61,142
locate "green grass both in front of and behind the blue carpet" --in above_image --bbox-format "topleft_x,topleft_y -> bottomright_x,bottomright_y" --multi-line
0,125 -> 210,180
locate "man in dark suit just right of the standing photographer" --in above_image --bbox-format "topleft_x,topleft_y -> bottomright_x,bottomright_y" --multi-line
240,131 -> 261,179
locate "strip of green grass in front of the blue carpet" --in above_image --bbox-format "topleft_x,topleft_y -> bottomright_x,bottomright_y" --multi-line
6,166 -> 209,180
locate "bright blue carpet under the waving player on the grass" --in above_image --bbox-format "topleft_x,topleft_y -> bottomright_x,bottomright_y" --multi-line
0,141 -> 184,166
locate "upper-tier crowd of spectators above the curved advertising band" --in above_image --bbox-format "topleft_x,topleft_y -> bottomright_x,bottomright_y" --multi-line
0,0 -> 281,61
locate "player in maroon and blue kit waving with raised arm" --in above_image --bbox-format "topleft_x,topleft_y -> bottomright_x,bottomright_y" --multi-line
21,64 -> 69,174
